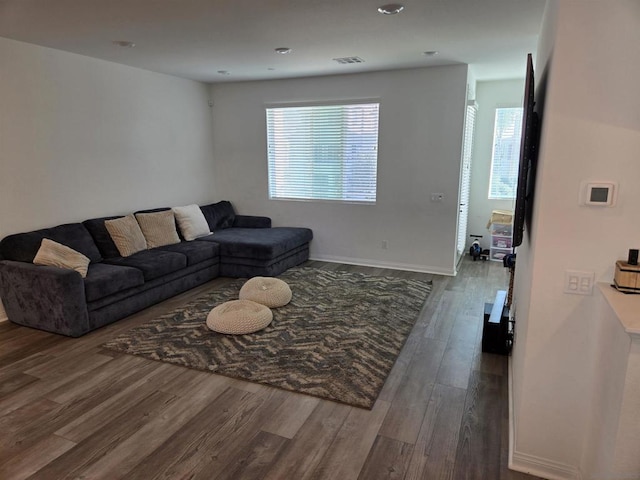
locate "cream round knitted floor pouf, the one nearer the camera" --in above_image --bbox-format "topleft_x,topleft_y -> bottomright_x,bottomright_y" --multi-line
207,300 -> 273,335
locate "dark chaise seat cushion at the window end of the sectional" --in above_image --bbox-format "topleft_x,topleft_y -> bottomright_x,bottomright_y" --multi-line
198,227 -> 313,260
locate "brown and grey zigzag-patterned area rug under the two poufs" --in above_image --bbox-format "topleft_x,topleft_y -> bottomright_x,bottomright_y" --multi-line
104,267 -> 431,408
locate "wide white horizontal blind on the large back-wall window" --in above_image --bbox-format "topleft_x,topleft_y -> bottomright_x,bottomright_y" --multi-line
266,103 -> 380,203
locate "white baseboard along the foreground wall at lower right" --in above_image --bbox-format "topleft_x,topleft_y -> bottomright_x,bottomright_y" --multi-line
508,357 -> 582,480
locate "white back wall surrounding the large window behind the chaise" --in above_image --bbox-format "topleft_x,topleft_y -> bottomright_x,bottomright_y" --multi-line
212,66 -> 467,274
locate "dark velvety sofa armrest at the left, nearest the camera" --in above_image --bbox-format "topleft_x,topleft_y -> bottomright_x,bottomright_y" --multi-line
0,260 -> 90,337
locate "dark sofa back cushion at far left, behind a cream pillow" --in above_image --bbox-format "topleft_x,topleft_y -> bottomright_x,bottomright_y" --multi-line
0,223 -> 102,263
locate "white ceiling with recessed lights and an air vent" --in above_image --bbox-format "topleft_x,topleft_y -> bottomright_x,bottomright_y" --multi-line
0,0 -> 545,82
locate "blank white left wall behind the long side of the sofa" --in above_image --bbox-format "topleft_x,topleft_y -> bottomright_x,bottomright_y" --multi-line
0,38 -> 214,238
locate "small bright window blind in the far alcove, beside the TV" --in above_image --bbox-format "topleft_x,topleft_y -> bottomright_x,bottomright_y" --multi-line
489,107 -> 522,199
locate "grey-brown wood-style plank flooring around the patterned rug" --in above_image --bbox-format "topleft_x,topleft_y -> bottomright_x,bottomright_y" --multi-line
0,259 -> 534,480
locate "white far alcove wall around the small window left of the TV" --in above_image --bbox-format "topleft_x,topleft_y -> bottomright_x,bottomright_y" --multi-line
467,78 -> 526,248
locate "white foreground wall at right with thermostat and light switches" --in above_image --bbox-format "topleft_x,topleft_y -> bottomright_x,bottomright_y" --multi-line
513,0 -> 640,478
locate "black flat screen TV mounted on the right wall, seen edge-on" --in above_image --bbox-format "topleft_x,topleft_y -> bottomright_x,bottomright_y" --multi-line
513,54 -> 540,247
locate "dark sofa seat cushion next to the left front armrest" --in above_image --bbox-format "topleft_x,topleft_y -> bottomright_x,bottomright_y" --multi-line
84,263 -> 144,302
